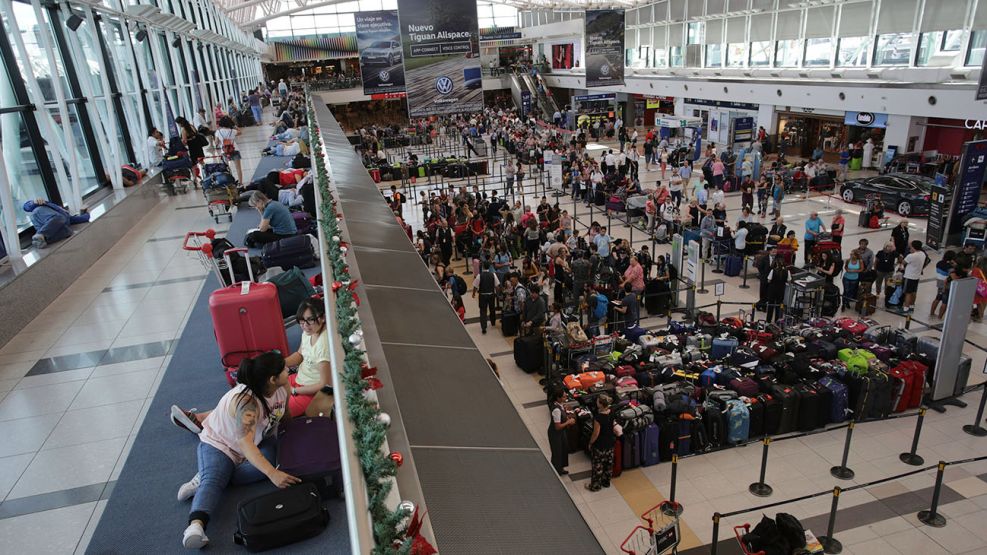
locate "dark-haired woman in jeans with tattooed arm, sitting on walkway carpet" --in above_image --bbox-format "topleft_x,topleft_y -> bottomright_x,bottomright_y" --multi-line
172,351 -> 301,549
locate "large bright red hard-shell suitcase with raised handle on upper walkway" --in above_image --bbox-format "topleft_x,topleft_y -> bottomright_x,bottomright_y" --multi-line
209,248 -> 290,386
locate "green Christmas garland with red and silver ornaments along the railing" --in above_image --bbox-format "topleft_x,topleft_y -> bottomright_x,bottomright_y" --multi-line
307,98 -> 434,555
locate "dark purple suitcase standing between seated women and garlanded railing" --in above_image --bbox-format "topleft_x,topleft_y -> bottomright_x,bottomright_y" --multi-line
278,416 -> 343,499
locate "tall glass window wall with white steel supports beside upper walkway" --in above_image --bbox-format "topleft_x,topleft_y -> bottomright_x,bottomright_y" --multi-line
0,0 -> 261,232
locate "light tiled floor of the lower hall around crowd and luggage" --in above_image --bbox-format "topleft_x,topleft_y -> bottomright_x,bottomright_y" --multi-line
396,138 -> 987,555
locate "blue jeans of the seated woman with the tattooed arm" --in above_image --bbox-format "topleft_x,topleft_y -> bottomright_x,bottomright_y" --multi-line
189,438 -> 278,524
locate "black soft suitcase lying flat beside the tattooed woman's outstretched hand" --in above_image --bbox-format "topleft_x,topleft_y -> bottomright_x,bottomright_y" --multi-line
233,484 -> 329,552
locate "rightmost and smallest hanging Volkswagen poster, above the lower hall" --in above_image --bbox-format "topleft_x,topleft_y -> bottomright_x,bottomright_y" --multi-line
586,10 -> 624,88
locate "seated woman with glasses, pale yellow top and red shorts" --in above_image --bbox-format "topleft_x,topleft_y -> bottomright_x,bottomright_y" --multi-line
285,299 -> 332,415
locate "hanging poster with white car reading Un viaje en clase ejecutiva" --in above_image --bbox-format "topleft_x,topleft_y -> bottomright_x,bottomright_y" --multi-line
355,10 -> 404,95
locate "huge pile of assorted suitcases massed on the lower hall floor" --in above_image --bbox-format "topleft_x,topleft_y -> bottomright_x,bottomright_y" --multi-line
544,312 -> 944,471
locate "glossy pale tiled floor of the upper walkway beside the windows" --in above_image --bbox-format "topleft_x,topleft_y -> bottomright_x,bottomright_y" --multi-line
0,117 -> 269,554
